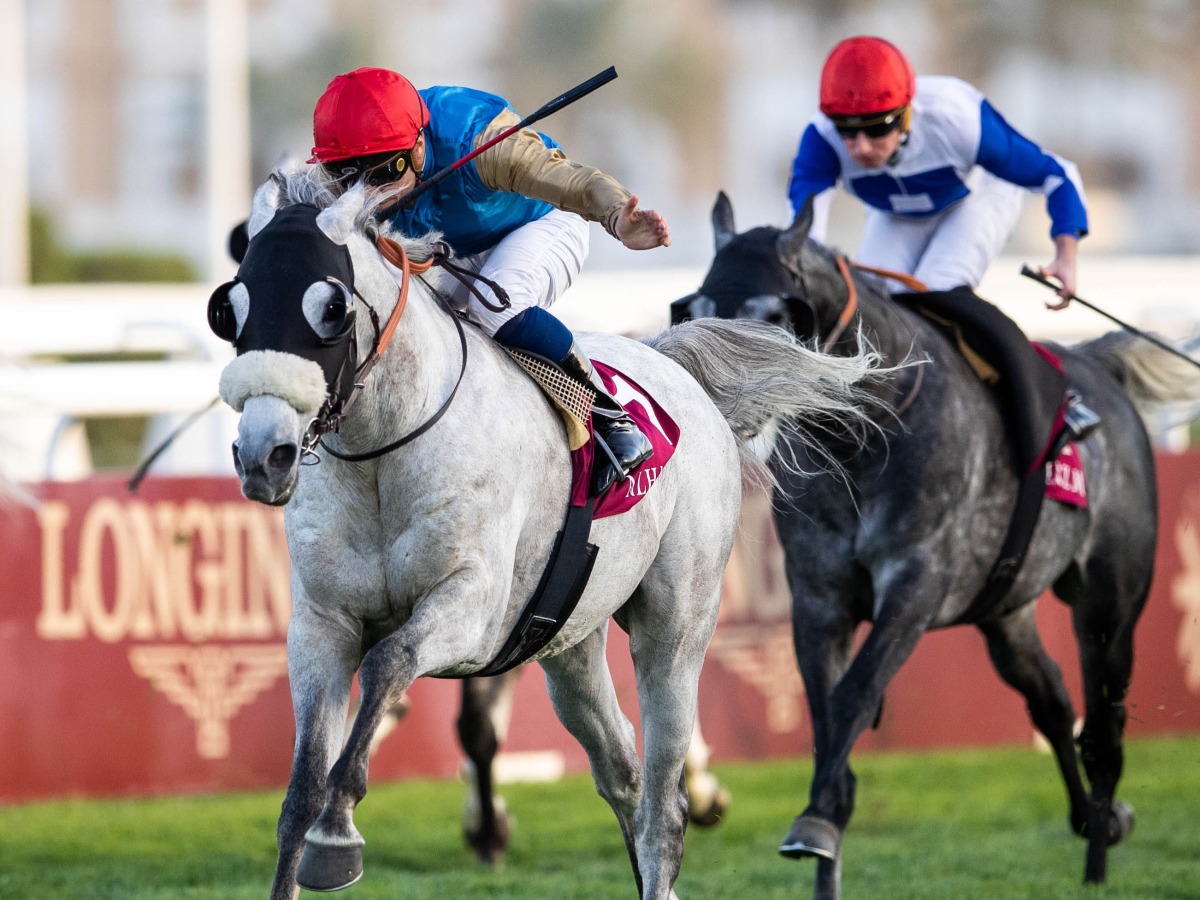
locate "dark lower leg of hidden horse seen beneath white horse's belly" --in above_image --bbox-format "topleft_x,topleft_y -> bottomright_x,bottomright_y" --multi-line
457,668 -> 521,865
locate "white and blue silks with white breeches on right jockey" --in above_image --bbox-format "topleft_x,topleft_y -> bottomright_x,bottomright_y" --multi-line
788,76 -> 1087,293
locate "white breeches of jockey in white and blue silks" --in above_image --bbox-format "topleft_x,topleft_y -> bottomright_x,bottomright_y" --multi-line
856,168 -> 1025,290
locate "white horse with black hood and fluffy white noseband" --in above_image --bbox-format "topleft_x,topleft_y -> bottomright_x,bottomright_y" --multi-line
210,170 -> 874,900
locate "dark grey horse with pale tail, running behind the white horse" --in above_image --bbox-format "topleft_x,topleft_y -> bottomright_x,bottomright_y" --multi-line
673,193 -> 1198,898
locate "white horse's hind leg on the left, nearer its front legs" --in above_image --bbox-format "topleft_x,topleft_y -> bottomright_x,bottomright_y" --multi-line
539,625 -> 648,898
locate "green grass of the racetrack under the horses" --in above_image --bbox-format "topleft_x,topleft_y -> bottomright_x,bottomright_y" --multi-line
0,737 -> 1200,900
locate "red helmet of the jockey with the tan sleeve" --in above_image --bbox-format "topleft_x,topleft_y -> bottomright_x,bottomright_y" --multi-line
308,68 -> 430,162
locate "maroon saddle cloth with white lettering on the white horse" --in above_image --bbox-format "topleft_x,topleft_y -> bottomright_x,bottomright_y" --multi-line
571,360 -> 679,518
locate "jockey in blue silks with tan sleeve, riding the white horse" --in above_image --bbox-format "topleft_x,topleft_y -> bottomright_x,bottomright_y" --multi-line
310,68 -> 671,493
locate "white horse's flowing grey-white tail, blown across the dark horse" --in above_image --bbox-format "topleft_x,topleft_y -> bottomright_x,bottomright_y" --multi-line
646,318 -> 892,482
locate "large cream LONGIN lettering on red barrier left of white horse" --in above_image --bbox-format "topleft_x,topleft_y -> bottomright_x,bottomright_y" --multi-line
37,497 -> 290,643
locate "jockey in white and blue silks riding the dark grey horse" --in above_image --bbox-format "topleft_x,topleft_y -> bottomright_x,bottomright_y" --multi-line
788,36 -> 1099,464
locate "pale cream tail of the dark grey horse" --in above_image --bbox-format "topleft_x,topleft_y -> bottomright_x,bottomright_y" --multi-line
1076,331 -> 1200,409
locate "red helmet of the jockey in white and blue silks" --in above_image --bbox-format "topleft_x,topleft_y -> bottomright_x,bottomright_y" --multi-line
821,37 -> 917,118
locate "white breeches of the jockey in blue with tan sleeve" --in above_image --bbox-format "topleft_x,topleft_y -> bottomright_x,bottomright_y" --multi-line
441,209 -> 589,336
